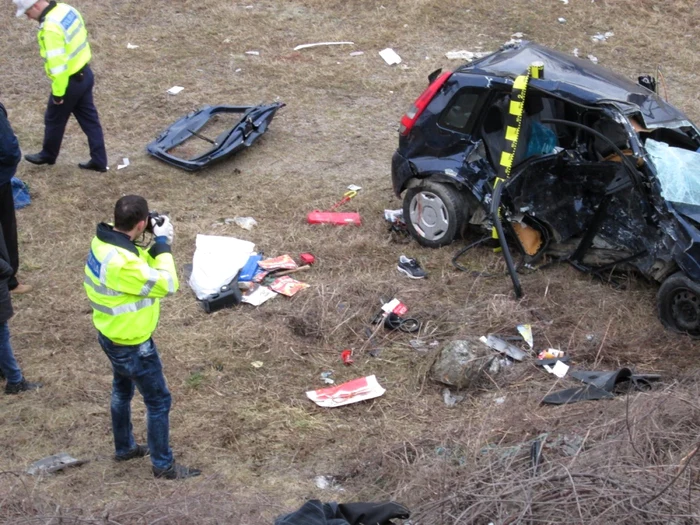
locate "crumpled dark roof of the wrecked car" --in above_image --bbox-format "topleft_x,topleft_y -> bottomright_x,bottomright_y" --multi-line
459,41 -> 688,128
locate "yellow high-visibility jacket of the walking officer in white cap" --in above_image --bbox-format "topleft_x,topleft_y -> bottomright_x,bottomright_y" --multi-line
38,4 -> 92,97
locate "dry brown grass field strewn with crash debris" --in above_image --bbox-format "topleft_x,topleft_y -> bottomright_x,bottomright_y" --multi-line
0,0 -> 700,525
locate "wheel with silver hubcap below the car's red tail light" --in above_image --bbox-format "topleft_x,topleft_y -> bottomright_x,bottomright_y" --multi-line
403,182 -> 468,248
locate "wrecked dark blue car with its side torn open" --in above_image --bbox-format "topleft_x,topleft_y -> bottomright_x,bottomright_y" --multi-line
392,42 -> 700,338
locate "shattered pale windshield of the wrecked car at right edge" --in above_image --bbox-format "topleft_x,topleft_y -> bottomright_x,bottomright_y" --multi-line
645,139 -> 700,206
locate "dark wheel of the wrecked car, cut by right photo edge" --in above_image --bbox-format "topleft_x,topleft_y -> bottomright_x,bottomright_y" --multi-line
656,272 -> 700,339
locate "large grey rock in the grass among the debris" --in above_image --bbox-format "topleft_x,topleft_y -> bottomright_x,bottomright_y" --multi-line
431,337 -> 498,389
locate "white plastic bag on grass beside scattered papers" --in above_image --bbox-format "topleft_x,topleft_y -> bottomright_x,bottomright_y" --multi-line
190,234 -> 255,300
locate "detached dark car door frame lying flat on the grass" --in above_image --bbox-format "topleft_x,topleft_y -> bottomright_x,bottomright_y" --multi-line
146,103 -> 284,171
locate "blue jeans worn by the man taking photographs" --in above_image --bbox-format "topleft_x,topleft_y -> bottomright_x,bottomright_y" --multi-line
97,333 -> 173,469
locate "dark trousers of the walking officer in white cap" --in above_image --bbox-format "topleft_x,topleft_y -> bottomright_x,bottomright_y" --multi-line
41,66 -> 107,167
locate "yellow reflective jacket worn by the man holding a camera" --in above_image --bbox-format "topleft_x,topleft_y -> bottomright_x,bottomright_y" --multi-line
84,223 -> 179,345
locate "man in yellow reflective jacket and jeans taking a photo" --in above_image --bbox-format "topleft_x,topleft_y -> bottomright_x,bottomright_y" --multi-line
84,195 -> 200,479
